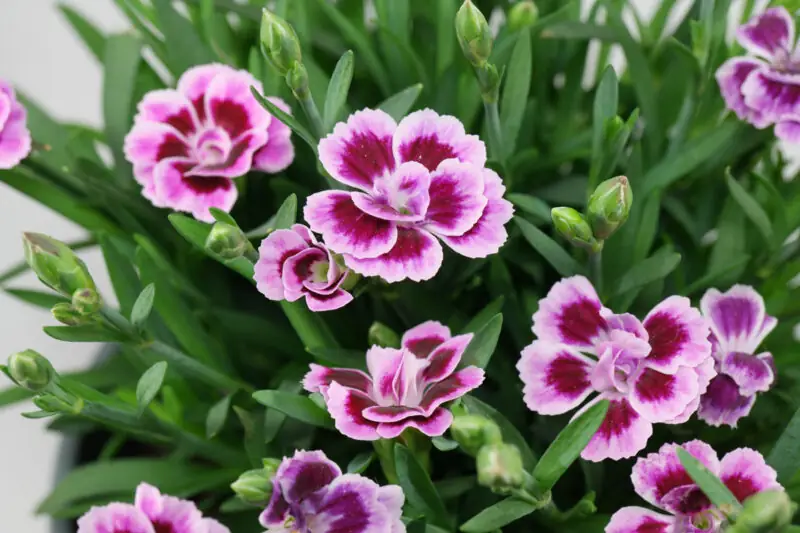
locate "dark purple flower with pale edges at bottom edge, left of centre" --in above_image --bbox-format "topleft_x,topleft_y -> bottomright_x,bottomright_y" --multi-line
259,451 -> 406,533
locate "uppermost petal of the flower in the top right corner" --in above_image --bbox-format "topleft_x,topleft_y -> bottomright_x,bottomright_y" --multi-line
736,7 -> 794,59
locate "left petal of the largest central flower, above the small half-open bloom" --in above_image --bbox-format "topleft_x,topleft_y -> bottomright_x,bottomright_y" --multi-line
303,191 -> 398,258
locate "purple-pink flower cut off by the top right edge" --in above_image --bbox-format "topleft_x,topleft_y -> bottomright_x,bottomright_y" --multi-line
716,7 -> 800,142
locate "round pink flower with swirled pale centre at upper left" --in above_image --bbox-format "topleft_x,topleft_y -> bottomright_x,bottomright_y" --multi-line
125,64 -> 294,222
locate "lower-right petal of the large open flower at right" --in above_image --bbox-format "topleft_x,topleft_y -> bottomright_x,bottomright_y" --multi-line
629,367 -> 700,422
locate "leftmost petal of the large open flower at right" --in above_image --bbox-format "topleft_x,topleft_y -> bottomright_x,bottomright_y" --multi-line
517,340 -> 595,415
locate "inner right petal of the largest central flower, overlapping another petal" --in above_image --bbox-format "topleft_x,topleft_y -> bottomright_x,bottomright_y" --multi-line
425,159 -> 488,236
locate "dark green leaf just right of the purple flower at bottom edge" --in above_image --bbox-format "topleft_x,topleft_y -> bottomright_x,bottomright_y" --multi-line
394,444 -> 450,530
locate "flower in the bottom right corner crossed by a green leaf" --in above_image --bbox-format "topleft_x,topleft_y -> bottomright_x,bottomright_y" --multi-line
606,440 -> 783,533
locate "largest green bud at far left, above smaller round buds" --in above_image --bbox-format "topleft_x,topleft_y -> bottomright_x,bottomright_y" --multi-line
22,233 -> 96,298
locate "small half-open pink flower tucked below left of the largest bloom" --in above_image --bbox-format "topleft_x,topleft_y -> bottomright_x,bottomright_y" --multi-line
253,224 -> 353,311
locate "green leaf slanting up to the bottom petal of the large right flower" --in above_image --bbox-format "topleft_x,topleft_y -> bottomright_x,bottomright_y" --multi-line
533,400 -> 609,491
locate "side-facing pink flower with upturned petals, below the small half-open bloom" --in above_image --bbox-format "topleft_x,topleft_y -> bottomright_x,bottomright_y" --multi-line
303,321 -> 483,440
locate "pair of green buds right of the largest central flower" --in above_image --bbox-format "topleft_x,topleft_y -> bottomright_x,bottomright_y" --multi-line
550,176 -> 633,249
